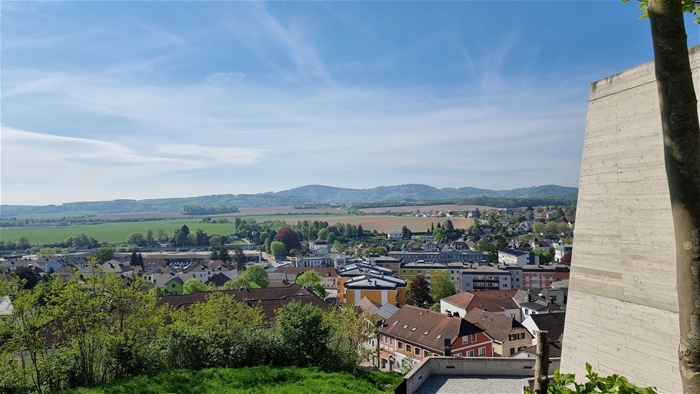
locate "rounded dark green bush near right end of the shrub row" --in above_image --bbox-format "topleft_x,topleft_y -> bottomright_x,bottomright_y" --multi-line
277,301 -> 330,367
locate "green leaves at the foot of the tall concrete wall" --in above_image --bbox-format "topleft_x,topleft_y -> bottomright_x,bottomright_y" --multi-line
525,363 -> 656,394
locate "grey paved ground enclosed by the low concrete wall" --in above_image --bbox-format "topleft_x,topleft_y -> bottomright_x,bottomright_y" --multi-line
416,375 -> 523,394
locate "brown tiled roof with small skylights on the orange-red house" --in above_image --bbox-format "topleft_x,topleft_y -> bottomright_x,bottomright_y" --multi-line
381,305 -> 483,353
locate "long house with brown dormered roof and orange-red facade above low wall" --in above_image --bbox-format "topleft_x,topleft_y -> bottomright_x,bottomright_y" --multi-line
379,305 -> 493,371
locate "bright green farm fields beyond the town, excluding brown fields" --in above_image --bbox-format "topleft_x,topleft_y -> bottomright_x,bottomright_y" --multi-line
0,215 -> 349,245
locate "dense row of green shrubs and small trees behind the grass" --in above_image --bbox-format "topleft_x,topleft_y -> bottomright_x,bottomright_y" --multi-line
0,272 -> 376,394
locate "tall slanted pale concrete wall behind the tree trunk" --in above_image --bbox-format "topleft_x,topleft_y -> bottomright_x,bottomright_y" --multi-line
562,47 -> 700,392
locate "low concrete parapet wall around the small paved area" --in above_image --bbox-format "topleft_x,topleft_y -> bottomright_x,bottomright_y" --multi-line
404,357 -> 560,394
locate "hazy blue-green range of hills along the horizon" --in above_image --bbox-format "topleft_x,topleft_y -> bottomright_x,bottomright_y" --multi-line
0,184 -> 578,217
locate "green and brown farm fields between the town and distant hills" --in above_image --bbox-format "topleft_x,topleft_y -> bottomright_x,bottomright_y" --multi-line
0,213 -> 473,245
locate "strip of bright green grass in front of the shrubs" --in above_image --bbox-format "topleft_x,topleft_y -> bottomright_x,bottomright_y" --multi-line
62,367 -> 403,394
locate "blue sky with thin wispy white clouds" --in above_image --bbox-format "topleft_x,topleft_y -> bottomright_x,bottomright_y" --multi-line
0,0 -> 699,204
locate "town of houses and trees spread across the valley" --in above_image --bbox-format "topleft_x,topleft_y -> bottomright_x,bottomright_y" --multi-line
0,205 -> 575,392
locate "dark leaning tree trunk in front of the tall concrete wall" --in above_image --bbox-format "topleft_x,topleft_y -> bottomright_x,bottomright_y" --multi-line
648,0 -> 700,393
